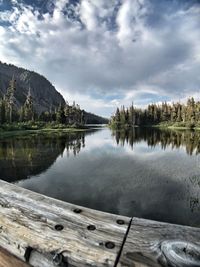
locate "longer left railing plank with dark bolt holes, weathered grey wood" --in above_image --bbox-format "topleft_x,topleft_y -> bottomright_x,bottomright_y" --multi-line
0,181 -> 130,267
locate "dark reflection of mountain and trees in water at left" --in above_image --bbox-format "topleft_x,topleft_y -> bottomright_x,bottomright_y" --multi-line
0,132 -> 85,182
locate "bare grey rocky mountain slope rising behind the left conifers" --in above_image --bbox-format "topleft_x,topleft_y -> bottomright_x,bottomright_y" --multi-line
0,61 -> 65,113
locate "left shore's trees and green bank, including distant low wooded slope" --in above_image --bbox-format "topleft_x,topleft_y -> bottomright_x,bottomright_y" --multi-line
0,76 -> 108,134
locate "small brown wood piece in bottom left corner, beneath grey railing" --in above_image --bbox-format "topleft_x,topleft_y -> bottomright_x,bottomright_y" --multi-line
0,247 -> 30,267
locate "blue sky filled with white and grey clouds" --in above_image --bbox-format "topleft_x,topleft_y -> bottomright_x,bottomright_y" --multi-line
0,0 -> 200,117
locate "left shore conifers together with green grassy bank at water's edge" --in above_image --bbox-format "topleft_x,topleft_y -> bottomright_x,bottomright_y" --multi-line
0,77 -> 85,131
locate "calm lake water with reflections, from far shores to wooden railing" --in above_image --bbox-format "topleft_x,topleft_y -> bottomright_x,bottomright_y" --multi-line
0,128 -> 200,226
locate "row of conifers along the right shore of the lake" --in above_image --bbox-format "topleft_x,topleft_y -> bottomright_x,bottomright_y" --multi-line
110,97 -> 200,128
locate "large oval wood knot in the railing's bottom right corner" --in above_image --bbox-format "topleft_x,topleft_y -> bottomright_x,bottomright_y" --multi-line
161,241 -> 200,267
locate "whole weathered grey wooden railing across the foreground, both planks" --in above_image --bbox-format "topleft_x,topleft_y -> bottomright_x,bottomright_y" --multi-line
0,180 -> 200,267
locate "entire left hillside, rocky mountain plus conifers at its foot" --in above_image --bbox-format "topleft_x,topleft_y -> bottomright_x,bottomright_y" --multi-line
0,61 -> 108,126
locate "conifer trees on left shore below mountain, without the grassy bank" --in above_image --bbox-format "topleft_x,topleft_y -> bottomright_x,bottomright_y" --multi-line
0,77 -> 85,126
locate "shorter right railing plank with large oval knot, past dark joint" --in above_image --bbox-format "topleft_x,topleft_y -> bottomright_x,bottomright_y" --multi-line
117,218 -> 200,267
